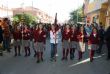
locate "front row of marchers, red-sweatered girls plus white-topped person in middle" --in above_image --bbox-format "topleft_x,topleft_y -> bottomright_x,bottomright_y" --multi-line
0,23 -> 99,63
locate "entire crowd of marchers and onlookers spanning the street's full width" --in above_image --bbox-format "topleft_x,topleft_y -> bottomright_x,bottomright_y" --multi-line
0,18 -> 110,63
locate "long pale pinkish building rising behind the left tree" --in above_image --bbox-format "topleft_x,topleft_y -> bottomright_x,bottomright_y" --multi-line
13,7 -> 53,23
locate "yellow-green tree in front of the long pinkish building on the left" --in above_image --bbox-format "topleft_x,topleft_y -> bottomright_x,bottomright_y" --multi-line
13,13 -> 37,25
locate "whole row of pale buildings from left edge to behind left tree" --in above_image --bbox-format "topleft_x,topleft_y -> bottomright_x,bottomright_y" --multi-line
0,6 -> 54,23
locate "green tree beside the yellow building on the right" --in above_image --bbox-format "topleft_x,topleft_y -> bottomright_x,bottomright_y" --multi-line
69,7 -> 83,24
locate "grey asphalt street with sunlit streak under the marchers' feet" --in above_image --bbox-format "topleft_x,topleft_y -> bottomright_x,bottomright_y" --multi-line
0,40 -> 110,74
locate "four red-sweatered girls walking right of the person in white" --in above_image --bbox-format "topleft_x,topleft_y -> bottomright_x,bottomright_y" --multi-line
62,25 -> 99,62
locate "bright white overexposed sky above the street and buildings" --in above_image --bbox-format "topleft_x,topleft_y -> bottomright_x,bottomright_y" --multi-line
0,0 -> 83,22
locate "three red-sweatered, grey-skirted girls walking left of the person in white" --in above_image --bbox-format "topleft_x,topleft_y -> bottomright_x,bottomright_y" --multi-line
13,24 -> 46,62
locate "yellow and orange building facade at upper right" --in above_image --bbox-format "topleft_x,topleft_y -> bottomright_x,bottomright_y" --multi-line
84,0 -> 109,26
